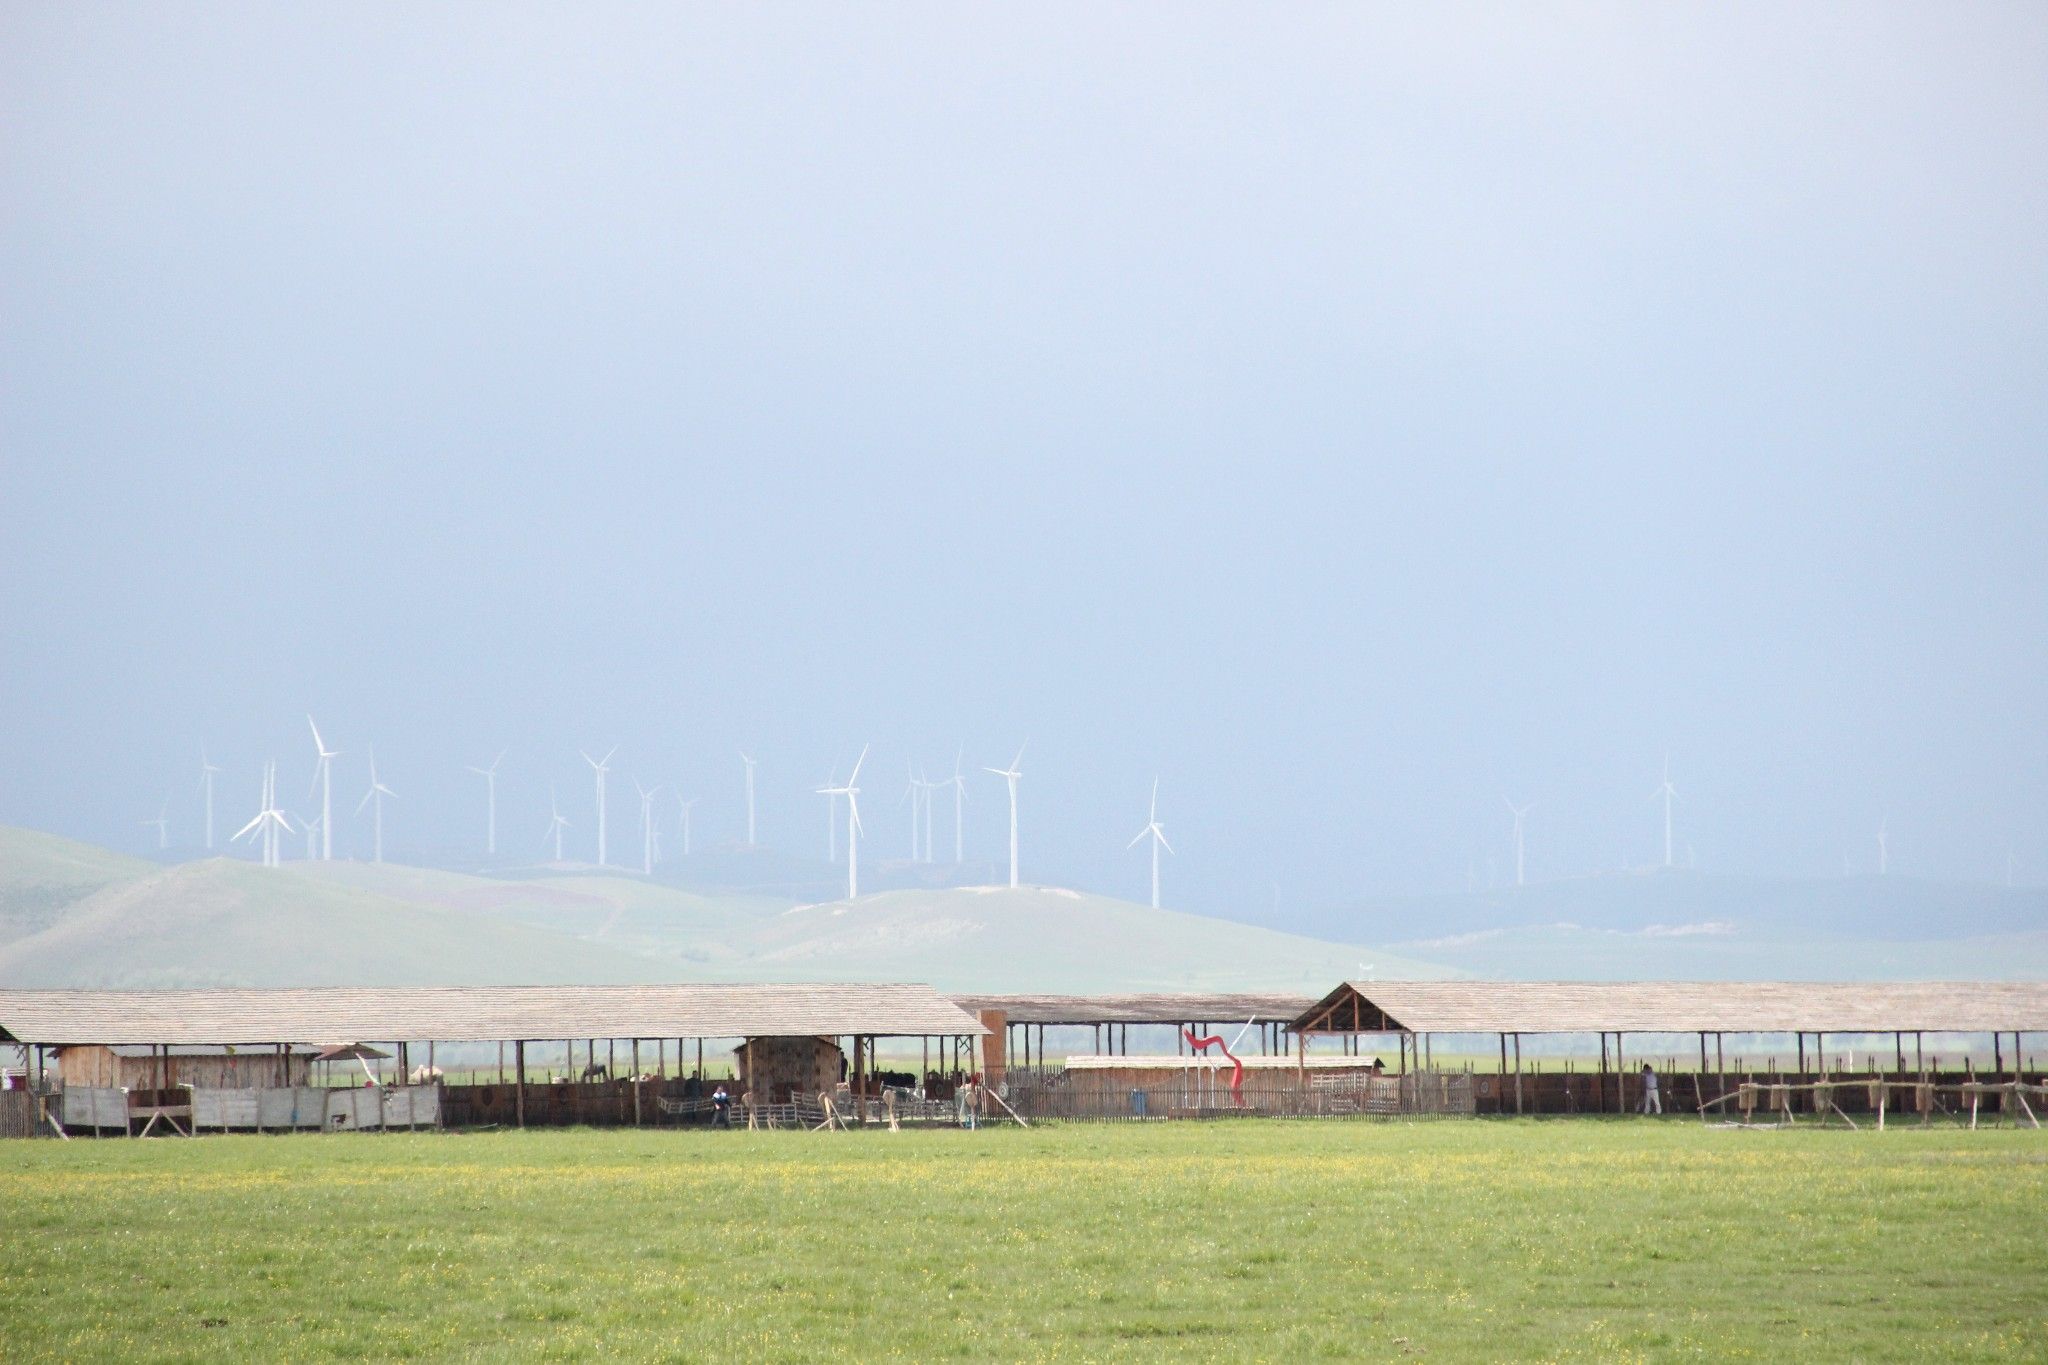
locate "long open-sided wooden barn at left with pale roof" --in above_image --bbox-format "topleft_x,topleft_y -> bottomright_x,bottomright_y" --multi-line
0,982 -> 983,1132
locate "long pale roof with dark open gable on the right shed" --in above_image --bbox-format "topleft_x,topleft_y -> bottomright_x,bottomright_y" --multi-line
1294,980 -> 2048,1033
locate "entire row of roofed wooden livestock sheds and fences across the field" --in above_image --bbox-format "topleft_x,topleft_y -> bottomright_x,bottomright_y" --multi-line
0,982 -> 2048,1134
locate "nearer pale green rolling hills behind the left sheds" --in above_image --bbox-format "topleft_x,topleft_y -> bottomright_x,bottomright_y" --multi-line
0,831 -> 1446,993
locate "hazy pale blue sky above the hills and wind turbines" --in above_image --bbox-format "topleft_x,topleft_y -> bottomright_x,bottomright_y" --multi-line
0,4 -> 2048,923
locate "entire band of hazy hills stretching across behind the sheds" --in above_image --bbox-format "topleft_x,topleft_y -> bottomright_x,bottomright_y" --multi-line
0,829 -> 2048,993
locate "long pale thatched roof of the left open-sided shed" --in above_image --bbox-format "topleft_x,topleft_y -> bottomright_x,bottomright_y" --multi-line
0,984 -> 983,1044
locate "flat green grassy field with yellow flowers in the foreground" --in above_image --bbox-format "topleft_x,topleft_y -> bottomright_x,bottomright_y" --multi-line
0,1119 -> 2048,1361
